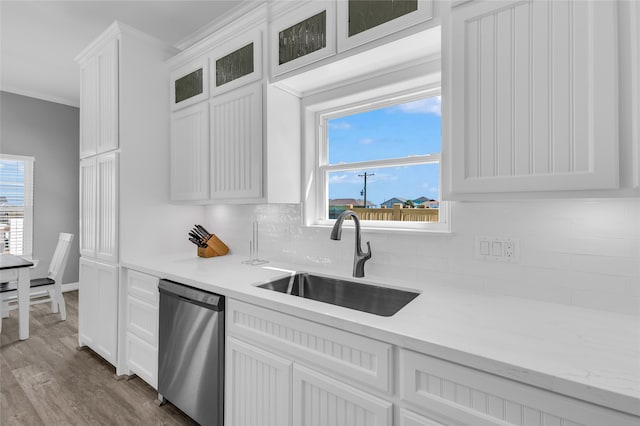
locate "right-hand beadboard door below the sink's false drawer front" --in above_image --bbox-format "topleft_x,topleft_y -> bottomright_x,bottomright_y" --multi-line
293,365 -> 393,426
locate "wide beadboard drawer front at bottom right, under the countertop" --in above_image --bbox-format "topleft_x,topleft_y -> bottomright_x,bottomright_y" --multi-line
400,349 -> 640,426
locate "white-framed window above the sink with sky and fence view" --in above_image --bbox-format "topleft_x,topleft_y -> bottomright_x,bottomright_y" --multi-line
306,89 -> 449,231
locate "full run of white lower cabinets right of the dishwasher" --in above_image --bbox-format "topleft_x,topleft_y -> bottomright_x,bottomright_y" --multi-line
225,299 -> 640,426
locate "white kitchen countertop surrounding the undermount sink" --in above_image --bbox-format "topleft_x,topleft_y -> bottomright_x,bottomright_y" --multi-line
122,253 -> 640,416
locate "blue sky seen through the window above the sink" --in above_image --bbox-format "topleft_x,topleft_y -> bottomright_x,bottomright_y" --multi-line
328,97 -> 442,204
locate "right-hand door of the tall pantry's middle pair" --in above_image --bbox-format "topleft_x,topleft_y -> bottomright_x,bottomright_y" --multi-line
96,152 -> 118,262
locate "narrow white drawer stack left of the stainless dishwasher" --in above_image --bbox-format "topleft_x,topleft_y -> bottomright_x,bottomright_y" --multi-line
125,270 -> 159,388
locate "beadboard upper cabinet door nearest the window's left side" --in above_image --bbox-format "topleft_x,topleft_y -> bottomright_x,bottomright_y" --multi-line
210,84 -> 262,200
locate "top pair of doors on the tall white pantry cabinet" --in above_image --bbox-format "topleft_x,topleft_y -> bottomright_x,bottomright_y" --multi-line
80,39 -> 118,158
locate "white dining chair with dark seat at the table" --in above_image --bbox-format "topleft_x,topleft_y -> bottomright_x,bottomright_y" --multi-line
0,233 -> 73,330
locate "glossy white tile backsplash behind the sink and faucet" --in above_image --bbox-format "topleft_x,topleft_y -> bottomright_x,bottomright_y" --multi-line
204,198 -> 640,315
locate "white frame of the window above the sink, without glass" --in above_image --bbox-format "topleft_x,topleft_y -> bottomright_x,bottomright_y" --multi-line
303,82 -> 451,233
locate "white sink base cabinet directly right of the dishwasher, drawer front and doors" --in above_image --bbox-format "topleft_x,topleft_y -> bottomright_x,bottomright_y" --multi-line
225,299 -> 393,426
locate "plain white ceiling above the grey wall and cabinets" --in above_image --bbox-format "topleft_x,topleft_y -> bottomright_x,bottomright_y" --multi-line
0,0 -> 248,106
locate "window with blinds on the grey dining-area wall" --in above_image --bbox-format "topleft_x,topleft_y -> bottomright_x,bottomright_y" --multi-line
0,154 -> 34,256
